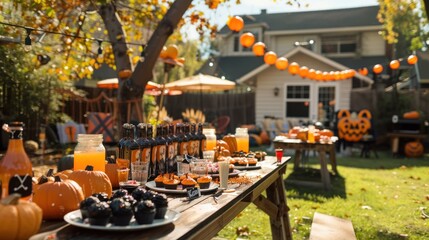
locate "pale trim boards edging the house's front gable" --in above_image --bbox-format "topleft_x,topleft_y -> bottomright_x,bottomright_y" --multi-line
236,46 -> 373,84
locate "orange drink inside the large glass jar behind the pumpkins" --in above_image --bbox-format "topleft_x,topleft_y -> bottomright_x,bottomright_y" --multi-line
73,151 -> 106,172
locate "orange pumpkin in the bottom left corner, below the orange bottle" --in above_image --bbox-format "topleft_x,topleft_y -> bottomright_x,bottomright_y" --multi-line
0,193 -> 42,239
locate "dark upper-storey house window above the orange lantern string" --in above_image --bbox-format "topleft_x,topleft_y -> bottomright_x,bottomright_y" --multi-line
322,35 -> 357,54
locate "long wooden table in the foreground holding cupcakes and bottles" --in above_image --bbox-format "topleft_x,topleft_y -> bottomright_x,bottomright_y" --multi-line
31,156 -> 292,240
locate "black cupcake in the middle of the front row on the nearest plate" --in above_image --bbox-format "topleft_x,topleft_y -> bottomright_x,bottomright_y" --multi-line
110,198 -> 133,226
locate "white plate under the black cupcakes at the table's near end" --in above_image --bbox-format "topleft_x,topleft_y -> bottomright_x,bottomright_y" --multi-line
64,209 -> 180,231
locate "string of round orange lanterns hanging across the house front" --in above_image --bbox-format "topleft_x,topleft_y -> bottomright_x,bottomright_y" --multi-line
227,16 -> 418,81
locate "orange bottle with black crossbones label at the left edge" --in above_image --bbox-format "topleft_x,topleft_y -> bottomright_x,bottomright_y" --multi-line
0,122 -> 33,200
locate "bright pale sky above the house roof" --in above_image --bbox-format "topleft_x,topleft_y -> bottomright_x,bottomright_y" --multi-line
182,0 -> 378,38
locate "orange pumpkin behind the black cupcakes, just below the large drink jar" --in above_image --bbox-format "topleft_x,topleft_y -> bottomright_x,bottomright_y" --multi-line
69,165 -> 112,197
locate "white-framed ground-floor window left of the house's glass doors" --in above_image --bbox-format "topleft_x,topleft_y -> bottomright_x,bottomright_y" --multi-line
285,85 -> 310,118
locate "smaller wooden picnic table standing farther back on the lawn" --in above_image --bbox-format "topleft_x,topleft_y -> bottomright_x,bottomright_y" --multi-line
273,136 -> 338,190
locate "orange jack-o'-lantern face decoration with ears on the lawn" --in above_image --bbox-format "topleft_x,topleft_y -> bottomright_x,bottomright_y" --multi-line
337,109 -> 371,142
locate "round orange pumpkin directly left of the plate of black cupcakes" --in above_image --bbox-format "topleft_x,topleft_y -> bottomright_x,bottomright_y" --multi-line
33,176 -> 84,219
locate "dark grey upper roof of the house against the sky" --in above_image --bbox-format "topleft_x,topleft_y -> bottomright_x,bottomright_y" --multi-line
219,6 -> 381,34
